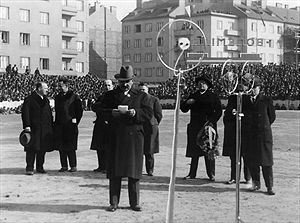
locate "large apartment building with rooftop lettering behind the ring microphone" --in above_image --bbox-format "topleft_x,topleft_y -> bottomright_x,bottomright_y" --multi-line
122,0 -> 300,83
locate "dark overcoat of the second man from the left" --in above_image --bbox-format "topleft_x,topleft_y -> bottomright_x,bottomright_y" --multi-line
54,91 -> 83,151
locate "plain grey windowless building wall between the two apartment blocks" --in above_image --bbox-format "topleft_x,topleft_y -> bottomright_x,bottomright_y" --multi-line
89,2 -> 122,79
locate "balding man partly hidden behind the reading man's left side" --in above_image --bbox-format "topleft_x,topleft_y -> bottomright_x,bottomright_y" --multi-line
90,79 -> 114,173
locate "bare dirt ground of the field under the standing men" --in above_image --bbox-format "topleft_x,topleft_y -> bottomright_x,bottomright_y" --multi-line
0,110 -> 300,223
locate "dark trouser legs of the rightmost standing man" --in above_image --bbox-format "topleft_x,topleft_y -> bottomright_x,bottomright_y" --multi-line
249,166 -> 273,188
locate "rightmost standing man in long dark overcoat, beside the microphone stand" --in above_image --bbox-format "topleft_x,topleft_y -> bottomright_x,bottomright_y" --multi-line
242,78 -> 276,195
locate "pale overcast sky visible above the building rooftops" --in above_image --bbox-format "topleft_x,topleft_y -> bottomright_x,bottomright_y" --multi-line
89,0 -> 300,20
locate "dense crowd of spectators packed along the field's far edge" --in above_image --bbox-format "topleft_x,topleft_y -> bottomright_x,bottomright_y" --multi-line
0,63 -> 300,113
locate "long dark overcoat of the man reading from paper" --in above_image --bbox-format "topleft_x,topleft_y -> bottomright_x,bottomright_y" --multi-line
103,88 -> 153,179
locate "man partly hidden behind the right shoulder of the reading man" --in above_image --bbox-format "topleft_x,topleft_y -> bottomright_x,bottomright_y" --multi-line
139,83 -> 163,176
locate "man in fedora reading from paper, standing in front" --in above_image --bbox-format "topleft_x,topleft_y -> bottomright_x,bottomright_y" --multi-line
102,66 -> 153,211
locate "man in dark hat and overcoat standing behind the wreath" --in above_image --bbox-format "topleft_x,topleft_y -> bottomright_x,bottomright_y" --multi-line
180,75 -> 222,181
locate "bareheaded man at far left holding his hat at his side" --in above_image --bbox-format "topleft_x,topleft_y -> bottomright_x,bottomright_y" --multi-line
21,82 -> 54,175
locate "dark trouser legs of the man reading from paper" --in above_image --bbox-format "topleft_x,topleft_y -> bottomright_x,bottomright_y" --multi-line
109,177 -> 140,206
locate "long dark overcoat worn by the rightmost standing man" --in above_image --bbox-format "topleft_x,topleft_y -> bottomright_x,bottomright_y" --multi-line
242,93 -> 276,166
